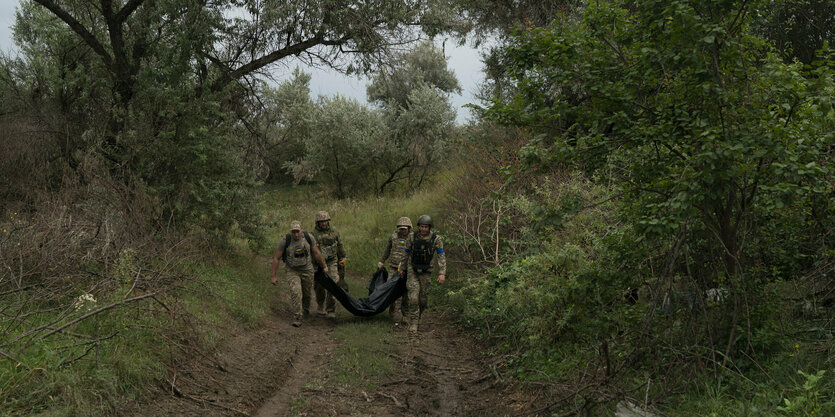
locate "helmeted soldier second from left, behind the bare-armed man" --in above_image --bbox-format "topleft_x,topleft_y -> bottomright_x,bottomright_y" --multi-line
313,211 -> 345,318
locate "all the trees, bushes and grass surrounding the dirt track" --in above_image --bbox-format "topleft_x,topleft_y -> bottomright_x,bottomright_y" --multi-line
0,0 -> 835,416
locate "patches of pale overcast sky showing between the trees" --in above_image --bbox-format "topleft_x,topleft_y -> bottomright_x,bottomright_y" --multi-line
0,0 -> 484,124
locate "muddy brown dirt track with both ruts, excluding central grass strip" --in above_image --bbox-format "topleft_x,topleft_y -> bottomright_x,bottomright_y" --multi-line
123,277 -> 541,417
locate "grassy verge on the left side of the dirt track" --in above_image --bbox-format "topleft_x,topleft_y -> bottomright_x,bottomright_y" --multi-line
0,249 -> 269,416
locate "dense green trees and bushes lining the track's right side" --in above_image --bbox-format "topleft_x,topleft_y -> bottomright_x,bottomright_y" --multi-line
440,1 -> 835,416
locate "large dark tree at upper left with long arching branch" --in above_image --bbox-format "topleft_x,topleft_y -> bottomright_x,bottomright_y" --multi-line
11,0 -> 458,234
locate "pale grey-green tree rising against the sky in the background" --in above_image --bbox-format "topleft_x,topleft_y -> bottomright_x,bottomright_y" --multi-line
368,42 -> 461,194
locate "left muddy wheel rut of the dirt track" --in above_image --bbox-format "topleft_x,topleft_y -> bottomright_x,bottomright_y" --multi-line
120,312 -> 337,417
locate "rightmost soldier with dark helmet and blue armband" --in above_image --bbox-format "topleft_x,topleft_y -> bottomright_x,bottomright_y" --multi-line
402,214 -> 446,334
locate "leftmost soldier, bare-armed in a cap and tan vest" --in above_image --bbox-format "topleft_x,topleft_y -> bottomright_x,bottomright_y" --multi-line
270,220 -> 328,327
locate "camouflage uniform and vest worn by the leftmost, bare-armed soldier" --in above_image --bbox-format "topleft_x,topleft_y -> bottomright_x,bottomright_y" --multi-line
276,228 -> 316,321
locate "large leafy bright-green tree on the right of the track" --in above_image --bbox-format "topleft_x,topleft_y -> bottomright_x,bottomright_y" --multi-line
487,0 -> 835,361
